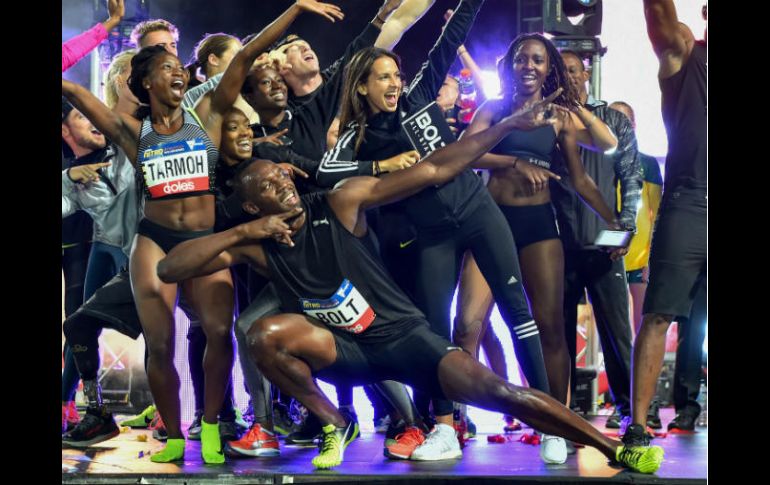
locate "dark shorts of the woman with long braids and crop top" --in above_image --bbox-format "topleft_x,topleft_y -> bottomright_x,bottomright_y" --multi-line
498,202 -> 559,251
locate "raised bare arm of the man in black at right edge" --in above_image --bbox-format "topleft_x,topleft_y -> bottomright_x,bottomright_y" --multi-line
644,0 -> 692,79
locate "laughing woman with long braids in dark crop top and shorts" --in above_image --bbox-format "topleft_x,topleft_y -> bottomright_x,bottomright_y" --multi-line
455,34 -> 617,403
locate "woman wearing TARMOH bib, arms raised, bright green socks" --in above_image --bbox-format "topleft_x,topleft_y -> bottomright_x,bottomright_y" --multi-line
62,2 -> 339,463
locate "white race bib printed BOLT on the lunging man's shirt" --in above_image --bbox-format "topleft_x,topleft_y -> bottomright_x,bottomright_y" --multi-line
299,279 -> 376,333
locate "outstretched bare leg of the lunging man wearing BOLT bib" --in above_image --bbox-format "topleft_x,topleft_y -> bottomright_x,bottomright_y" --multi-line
438,351 -> 621,459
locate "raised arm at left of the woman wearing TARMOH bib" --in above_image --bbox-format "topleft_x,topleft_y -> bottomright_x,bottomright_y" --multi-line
61,79 -> 141,163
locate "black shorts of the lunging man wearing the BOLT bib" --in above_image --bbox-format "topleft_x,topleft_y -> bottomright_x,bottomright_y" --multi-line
315,320 -> 462,398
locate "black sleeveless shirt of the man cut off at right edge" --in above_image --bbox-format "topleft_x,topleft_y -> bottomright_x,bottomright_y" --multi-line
660,41 -> 707,192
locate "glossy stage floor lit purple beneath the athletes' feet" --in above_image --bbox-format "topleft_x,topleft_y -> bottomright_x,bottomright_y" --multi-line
62,409 -> 708,485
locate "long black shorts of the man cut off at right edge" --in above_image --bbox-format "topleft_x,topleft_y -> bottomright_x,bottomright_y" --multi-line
642,188 -> 707,317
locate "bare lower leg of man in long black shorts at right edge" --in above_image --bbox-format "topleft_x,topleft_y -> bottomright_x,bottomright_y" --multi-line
631,313 -> 674,426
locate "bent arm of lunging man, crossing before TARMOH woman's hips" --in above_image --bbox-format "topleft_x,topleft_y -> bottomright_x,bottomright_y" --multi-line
158,207 -> 302,283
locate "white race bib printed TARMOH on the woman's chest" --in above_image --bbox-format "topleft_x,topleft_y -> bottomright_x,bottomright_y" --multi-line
139,138 -> 209,199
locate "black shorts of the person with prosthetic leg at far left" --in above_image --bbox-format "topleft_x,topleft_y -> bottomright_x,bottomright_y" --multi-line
67,269 -> 142,339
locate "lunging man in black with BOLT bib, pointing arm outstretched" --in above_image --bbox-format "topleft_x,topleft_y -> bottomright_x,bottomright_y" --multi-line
158,90 -> 663,473
